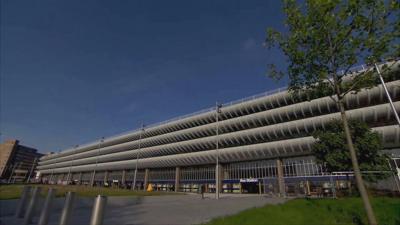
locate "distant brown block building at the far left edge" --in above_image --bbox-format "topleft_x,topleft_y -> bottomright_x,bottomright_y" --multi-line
0,140 -> 43,182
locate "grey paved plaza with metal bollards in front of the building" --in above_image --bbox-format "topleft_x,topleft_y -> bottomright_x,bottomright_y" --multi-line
0,194 -> 285,225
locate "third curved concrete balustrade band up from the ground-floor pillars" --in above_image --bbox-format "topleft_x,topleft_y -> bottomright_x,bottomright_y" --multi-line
39,81 -> 400,165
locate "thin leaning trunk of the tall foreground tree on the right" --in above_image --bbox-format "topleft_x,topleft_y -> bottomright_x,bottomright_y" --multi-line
338,100 -> 377,225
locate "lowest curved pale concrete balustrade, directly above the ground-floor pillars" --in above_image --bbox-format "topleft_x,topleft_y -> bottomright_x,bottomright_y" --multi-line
40,125 -> 400,174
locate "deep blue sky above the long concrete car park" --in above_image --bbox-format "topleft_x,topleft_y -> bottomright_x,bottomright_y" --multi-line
0,0 -> 285,152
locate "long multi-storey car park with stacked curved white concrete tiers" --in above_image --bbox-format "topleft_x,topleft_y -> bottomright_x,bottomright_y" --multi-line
38,62 -> 400,194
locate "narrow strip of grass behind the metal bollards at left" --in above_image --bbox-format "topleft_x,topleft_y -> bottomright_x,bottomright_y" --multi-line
0,185 -> 177,200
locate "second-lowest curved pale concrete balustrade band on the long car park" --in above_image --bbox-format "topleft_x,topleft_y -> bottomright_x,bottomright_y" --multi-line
38,102 -> 400,169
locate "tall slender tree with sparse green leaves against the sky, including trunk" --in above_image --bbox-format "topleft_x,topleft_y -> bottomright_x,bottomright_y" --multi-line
266,0 -> 400,224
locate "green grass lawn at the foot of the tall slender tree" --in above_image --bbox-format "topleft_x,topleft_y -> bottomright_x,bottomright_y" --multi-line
206,197 -> 400,225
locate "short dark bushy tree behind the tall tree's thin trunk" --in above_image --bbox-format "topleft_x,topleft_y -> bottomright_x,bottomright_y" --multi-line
312,120 -> 390,181
